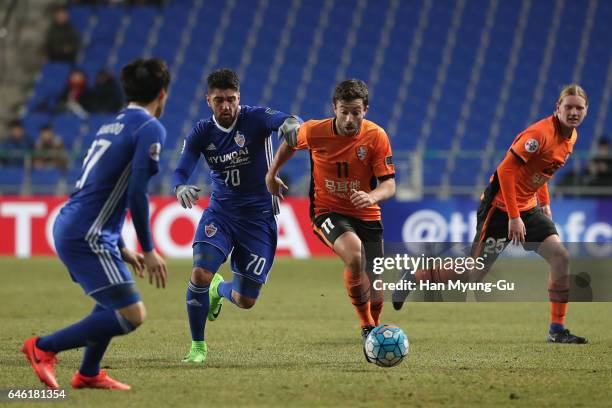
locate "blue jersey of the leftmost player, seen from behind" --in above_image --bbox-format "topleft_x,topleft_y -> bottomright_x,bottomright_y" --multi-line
58,105 -> 166,244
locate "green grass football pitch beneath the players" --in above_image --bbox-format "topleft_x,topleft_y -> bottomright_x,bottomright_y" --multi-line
0,258 -> 612,407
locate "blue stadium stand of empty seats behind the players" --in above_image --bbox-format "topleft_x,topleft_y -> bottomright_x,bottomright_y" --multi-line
9,0 -> 612,194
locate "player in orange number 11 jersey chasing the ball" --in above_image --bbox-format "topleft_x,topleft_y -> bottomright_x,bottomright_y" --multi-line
266,79 -> 395,360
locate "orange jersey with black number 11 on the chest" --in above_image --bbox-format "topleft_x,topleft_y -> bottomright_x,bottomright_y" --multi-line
294,118 -> 395,221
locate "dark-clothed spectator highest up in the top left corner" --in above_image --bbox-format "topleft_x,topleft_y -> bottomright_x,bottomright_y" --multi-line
45,7 -> 81,63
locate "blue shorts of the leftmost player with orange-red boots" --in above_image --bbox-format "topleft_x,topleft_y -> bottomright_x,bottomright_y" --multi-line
53,217 -> 140,309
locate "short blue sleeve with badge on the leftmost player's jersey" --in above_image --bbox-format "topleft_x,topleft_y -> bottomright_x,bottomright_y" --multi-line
132,119 -> 166,176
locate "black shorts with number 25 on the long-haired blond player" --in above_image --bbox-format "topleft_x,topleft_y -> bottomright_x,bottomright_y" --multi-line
472,202 -> 558,266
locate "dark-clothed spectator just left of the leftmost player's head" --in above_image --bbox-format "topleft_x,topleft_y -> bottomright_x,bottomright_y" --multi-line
81,69 -> 123,113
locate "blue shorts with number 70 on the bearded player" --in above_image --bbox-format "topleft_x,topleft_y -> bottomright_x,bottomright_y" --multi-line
194,209 -> 277,284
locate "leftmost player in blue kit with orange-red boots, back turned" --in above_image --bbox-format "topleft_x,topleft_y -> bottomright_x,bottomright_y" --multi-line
21,59 -> 170,390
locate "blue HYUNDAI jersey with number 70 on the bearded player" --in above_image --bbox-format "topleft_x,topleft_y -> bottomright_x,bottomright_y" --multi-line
172,105 -> 291,218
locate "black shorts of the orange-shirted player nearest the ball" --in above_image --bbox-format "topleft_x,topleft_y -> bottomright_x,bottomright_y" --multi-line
312,212 -> 383,271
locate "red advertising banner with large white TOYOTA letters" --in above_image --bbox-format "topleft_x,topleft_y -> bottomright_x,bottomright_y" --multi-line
0,196 -> 332,258
